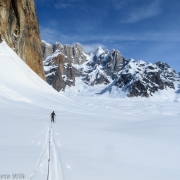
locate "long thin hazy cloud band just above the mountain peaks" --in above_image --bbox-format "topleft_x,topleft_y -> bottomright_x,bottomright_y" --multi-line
41,27 -> 180,45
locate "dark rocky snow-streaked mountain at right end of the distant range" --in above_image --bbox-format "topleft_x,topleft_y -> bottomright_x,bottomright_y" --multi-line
116,59 -> 179,97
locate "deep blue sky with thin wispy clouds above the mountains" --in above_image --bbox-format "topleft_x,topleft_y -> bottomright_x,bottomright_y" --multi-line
36,0 -> 180,72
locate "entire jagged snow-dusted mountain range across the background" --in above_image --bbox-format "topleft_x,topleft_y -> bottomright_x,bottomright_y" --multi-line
42,41 -> 180,97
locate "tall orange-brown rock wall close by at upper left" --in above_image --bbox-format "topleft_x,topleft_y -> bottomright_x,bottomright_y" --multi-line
0,0 -> 45,79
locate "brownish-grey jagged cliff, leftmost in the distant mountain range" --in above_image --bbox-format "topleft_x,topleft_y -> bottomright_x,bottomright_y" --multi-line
42,41 -> 87,91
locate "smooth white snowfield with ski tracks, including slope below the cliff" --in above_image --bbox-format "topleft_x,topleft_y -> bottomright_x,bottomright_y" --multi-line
0,42 -> 180,180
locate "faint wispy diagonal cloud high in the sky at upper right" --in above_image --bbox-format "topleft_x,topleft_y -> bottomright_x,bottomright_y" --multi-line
122,0 -> 161,23
